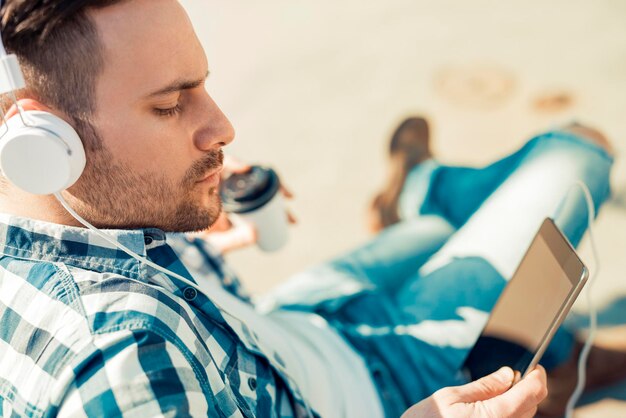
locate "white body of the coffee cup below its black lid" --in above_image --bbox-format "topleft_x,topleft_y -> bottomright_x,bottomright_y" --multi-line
237,192 -> 289,252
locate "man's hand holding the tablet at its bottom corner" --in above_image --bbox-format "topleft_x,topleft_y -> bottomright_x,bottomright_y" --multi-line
402,366 -> 548,418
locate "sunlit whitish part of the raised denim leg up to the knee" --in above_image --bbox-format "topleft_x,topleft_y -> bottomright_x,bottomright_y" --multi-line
420,132 -> 613,280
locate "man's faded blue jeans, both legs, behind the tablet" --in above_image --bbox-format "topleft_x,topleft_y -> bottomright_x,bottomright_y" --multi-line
266,131 -> 612,416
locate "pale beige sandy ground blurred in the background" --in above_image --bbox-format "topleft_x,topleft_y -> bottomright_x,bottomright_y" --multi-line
183,0 -> 626,417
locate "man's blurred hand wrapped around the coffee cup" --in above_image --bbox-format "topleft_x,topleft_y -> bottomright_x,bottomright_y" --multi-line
189,155 -> 296,254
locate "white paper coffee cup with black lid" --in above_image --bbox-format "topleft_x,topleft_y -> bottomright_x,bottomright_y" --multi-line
220,166 -> 289,252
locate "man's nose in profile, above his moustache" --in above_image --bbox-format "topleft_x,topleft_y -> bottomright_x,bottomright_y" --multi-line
194,95 -> 235,151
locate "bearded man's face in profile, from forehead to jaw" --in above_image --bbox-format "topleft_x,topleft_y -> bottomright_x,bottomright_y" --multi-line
69,0 -> 234,231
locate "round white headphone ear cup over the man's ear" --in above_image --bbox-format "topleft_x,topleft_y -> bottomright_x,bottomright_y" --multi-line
0,111 -> 86,195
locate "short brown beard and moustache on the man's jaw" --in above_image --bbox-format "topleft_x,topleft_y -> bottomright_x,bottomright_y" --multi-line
67,147 -> 224,232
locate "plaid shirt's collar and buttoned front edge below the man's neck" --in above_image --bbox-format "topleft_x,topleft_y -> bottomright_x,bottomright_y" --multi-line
0,213 -> 304,390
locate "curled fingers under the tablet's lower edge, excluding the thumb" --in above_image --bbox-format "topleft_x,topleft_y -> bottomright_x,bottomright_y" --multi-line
484,366 -> 548,417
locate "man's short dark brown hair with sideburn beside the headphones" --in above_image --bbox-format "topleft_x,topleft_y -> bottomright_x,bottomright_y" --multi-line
0,0 -> 127,150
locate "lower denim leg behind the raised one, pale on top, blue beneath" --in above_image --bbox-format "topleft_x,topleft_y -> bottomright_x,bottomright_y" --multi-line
259,216 -> 454,310
